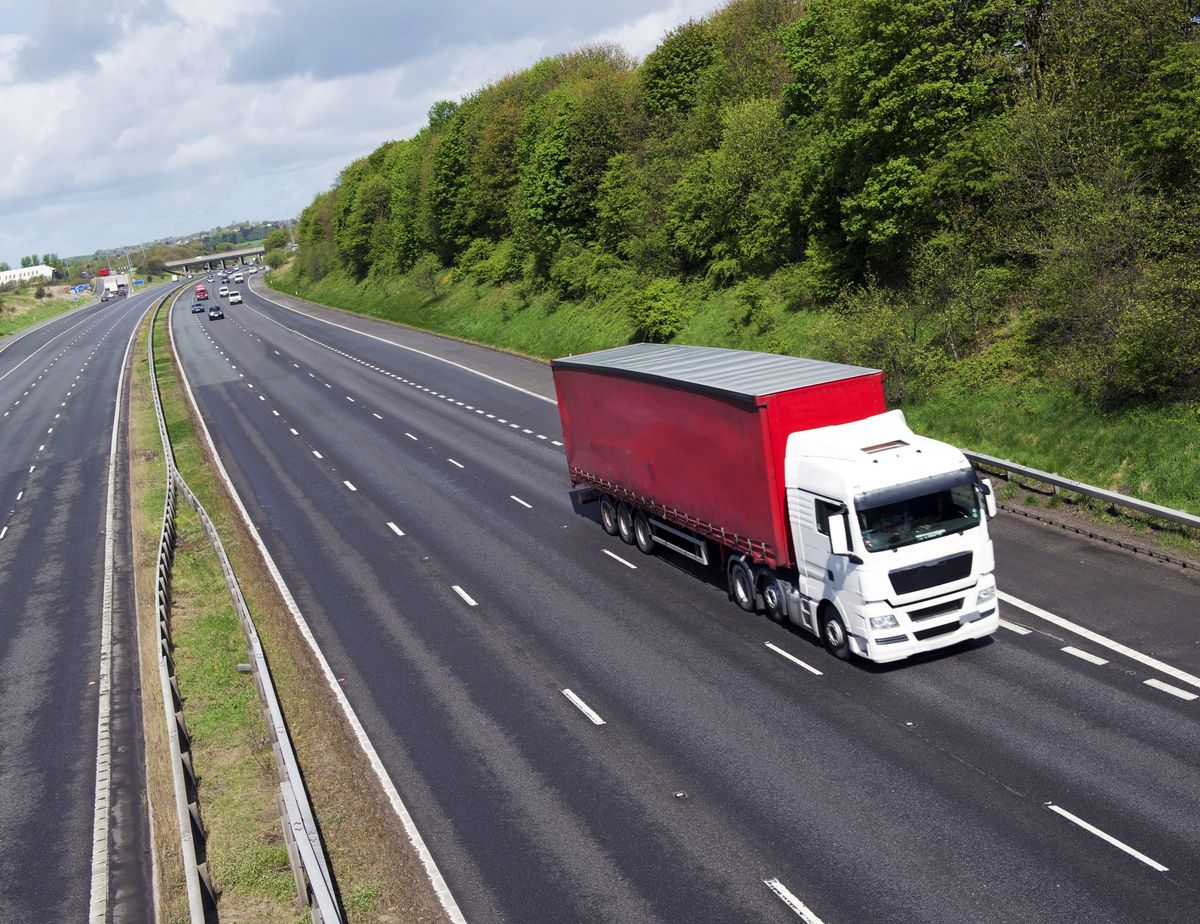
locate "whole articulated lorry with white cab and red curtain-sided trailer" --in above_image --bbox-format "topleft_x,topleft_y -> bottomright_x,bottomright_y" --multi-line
552,343 -> 1000,662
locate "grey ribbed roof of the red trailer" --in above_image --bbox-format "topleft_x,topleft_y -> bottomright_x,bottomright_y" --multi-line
552,343 -> 878,401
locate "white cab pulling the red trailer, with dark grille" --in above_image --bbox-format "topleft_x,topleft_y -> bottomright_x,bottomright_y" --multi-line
781,410 -> 1000,661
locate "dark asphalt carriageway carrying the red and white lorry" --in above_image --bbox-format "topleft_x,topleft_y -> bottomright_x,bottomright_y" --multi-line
172,282 -> 1200,924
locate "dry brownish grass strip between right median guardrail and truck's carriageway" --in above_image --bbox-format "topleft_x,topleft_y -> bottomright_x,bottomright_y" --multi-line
155,285 -> 444,922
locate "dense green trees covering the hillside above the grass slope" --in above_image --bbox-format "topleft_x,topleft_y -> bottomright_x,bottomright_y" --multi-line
294,0 -> 1200,408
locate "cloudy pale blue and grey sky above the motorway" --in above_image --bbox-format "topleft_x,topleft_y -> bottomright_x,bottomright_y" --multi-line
0,0 -> 722,266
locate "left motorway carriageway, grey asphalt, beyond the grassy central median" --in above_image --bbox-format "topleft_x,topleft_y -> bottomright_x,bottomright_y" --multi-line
0,284 -> 161,922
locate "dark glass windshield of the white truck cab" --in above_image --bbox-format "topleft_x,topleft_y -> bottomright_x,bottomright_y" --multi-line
854,470 -> 979,552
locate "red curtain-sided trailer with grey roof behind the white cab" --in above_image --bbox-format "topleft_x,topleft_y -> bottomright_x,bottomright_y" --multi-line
552,343 -> 887,568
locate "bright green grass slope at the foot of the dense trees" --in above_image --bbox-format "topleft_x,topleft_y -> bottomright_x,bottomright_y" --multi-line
269,264 -> 1200,545
